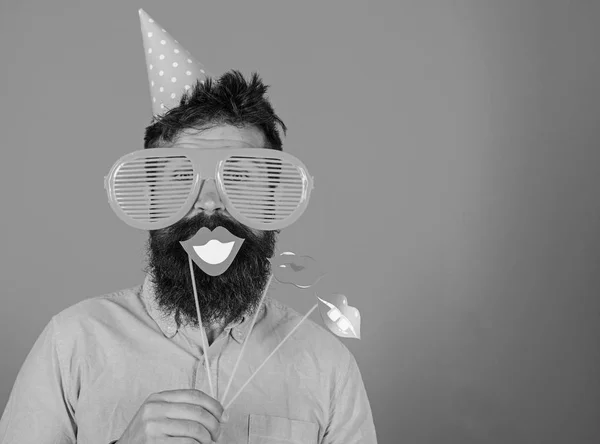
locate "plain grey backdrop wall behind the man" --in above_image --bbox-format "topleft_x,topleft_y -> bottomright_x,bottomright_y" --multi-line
0,0 -> 600,444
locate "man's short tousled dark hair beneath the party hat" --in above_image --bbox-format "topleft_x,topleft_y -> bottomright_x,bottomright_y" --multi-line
144,70 -> 287,151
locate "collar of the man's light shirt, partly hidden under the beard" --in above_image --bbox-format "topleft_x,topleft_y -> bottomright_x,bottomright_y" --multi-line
142,274 -> 268,344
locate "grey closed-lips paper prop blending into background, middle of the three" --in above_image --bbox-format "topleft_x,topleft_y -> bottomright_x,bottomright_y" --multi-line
269,251 -> 325,289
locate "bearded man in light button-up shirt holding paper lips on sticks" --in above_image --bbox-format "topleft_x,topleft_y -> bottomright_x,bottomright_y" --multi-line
0,10 -> 376,444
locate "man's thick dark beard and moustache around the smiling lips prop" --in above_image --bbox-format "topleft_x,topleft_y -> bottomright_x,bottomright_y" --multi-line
144,213 -> 279,328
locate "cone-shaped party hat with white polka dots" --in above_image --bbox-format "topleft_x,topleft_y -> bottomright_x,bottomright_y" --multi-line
138,9 -> 210,117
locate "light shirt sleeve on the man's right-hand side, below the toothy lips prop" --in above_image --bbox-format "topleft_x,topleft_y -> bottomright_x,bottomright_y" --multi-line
322,351 -> 377,444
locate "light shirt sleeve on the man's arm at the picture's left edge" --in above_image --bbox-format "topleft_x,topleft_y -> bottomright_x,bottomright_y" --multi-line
0,318 -> 77,444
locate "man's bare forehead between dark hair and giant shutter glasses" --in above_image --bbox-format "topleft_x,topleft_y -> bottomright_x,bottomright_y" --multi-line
170,125 -> 265,148
